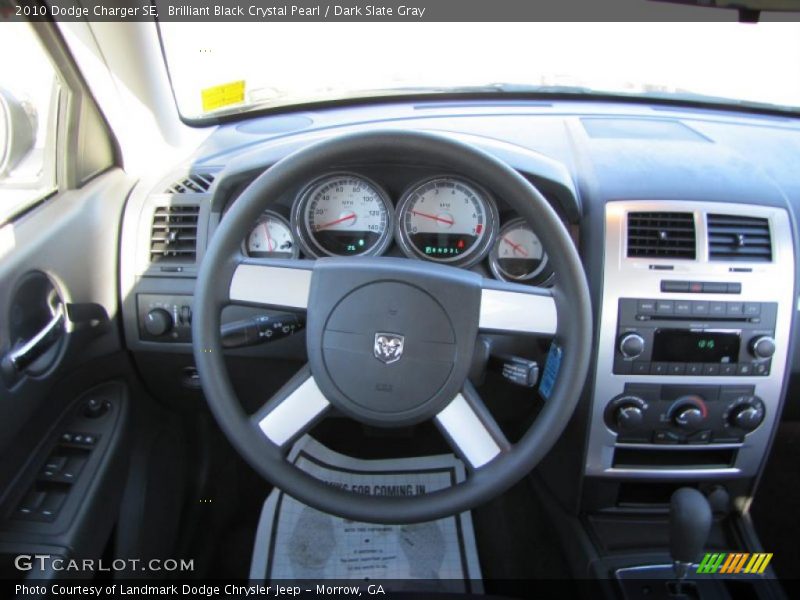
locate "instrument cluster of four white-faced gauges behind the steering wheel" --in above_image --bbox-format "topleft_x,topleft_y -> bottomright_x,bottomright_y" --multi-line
243,171 -> 552,284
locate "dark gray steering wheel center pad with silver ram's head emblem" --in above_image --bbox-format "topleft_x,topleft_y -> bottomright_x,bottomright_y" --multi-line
306,258 -> 481,426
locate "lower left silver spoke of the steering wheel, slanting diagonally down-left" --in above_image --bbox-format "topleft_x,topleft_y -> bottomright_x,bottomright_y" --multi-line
250,365 -> 330,449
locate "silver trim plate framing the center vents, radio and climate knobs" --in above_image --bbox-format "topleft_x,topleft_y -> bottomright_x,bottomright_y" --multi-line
585,200 -> 796,479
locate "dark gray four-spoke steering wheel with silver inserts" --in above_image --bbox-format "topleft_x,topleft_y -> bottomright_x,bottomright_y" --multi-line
192,131 -> 592,523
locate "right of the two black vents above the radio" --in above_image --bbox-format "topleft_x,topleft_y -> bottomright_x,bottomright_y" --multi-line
708,214 -> 772,262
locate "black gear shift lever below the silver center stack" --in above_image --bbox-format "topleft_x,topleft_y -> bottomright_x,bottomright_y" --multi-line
669,488 -> 711,586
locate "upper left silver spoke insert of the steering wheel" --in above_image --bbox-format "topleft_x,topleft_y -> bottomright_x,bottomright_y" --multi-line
229,258 -> 315,310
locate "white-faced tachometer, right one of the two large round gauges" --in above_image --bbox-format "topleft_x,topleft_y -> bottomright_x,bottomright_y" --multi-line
397,177 -> 497,266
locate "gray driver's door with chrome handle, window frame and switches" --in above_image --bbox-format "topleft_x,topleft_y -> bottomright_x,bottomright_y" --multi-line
0,22 -> 151,579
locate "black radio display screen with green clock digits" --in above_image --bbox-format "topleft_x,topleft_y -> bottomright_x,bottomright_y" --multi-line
651,329 -> 741,363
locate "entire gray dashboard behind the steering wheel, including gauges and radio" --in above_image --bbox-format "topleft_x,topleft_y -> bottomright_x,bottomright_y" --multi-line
120,101 -> 800,509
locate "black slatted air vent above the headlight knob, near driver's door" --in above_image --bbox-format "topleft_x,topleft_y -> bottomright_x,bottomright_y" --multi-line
150,204 -> 200,262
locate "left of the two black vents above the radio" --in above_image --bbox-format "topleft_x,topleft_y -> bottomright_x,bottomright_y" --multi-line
628,212 -> 695,260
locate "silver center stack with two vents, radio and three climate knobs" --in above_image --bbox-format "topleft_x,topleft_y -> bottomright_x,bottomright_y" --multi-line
585,201 -> 795,481
